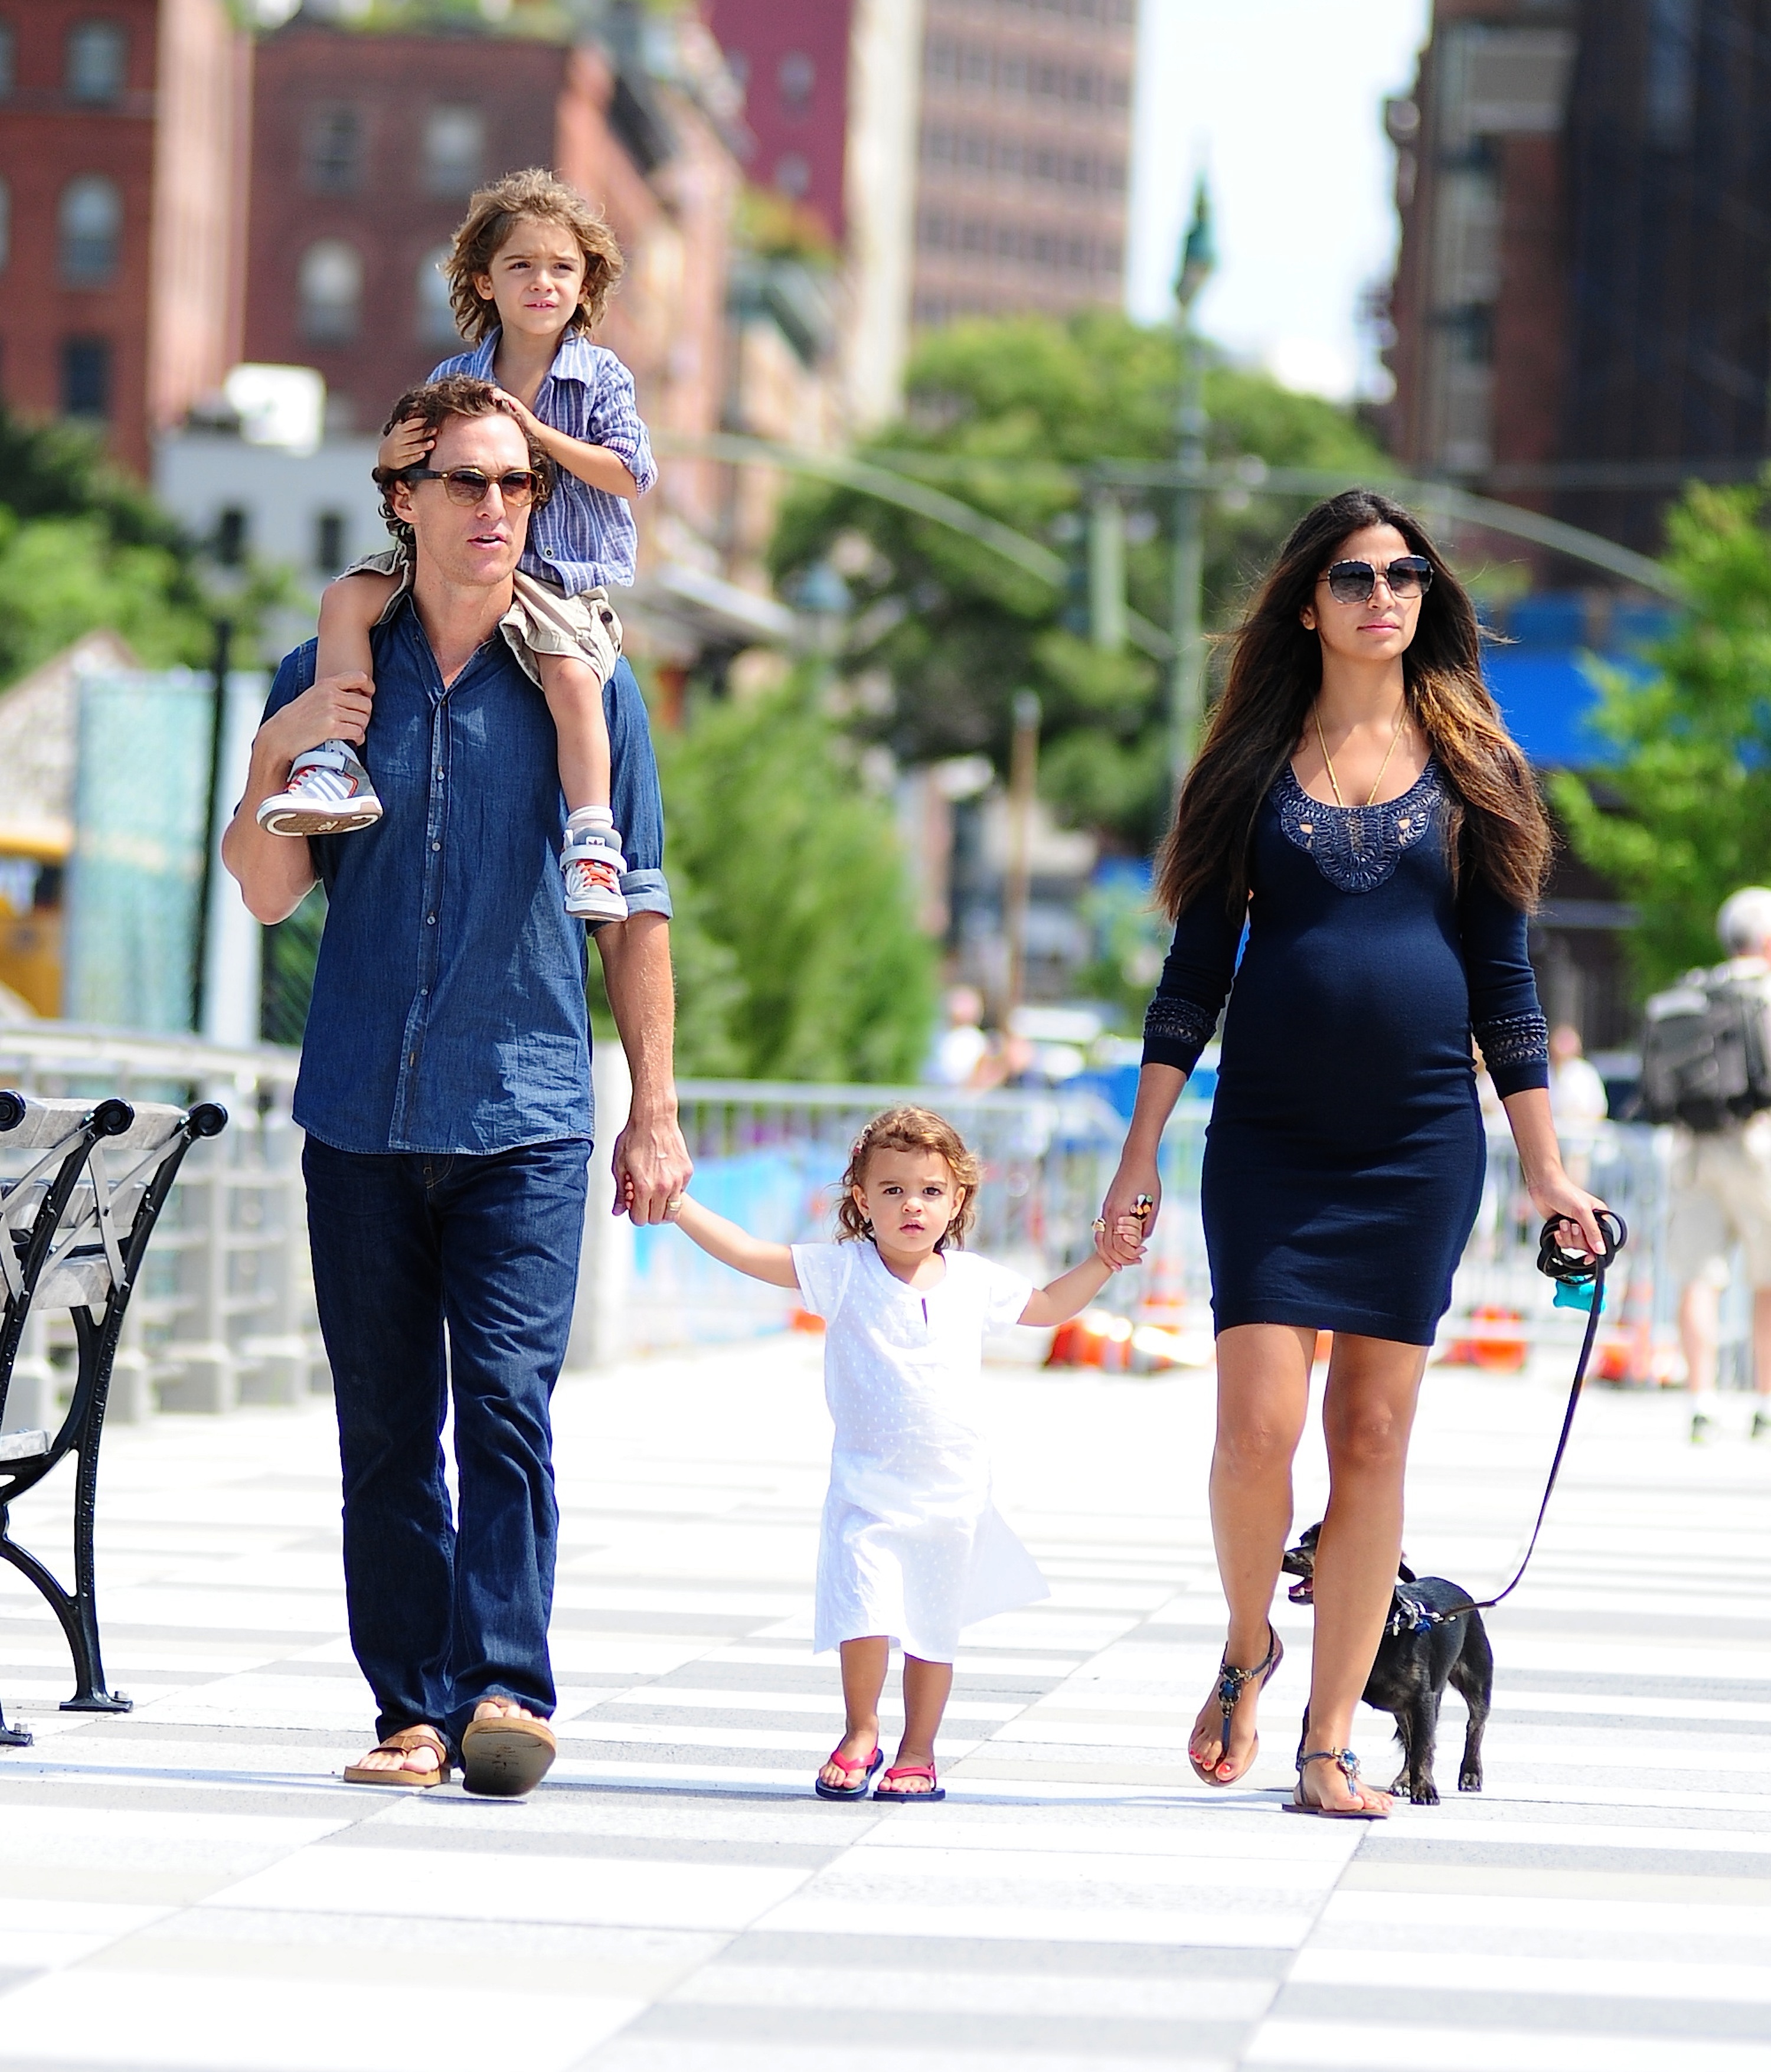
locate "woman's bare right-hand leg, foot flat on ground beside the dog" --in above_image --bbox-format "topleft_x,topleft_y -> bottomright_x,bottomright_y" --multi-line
1303,1332 -> 1427,1809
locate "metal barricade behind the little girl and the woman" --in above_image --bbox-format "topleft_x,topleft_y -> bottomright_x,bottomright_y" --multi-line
626,1080 -> 1707,1384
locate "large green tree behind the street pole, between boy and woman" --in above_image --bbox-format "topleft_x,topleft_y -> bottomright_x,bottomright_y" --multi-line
773,311 -> 1377,849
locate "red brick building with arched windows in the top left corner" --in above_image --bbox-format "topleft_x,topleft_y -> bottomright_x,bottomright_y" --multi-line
0,0 -> 251,475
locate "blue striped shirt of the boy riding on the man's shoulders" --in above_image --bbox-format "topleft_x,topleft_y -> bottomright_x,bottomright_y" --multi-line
431,332 -> 659,597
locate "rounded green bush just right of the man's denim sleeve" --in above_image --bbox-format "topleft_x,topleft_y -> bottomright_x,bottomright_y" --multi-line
659,674 -> 934,1081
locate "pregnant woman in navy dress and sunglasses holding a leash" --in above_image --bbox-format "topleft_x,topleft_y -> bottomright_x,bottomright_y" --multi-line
1102,491 -> 1601,1819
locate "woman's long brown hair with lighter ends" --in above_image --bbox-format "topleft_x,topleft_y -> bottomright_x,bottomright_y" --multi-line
1156,489 -> 1551,920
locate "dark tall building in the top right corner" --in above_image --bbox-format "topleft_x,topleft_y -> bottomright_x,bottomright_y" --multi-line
1390,0 -> 1771,551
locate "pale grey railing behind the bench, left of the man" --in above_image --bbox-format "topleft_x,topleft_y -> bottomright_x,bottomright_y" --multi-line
0,1021 -> 327,1427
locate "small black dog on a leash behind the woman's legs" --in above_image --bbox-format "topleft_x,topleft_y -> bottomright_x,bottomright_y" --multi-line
1282,1525 -> 1494,1807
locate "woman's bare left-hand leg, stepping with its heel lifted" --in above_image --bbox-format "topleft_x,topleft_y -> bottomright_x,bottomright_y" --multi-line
1189,1324 -> 1315,1784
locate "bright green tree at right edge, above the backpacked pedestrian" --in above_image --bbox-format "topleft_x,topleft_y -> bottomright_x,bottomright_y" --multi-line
1551,472 -> 1771,986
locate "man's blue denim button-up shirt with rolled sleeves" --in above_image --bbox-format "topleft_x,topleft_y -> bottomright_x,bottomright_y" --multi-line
265,601 -> 671,1154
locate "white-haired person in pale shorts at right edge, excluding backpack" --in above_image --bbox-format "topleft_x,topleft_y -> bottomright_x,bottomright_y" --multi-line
1668,885 -> 1771,1444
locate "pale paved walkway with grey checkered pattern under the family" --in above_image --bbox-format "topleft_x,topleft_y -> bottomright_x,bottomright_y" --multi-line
0,1341 -> 1771,2072
